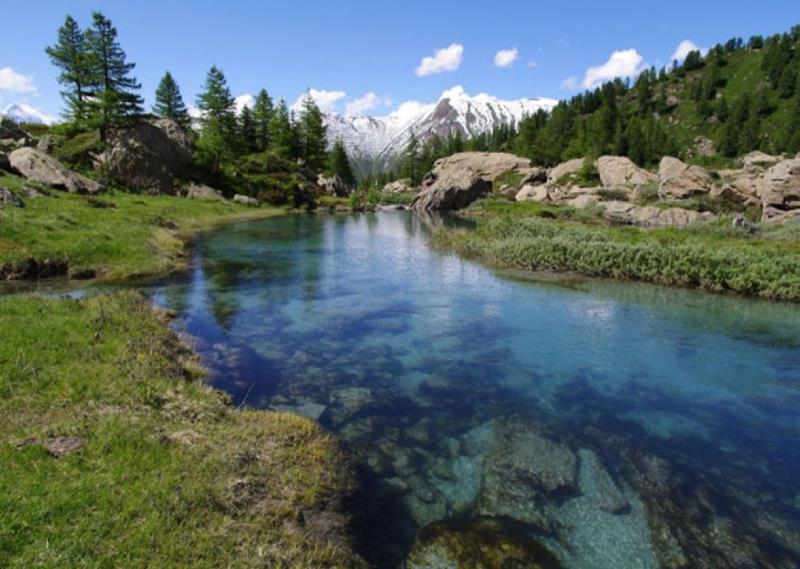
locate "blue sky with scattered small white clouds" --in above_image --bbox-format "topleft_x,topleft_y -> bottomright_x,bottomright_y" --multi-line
0,0 -> 800,121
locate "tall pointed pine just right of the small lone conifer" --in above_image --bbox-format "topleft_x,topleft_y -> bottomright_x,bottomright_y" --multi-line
197,66 -> 236,172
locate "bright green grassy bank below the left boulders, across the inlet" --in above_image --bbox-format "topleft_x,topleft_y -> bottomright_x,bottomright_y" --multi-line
0,174 -> 281,279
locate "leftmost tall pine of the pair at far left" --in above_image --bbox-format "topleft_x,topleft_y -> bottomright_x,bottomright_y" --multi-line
45,16 -> 91,127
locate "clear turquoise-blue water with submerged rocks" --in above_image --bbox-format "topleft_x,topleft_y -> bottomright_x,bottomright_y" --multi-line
145,212 -> 800,569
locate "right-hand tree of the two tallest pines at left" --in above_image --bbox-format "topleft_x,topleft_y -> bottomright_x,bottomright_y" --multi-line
85,12 -> 142,140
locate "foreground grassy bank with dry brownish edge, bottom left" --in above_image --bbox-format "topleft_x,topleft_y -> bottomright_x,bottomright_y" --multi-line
0,292 -> 368,568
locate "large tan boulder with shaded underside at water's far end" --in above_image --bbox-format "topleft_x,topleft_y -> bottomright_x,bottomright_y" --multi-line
411,152 -> 531,211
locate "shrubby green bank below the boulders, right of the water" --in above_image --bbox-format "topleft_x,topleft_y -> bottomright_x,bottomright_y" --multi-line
435,197 -> 800,301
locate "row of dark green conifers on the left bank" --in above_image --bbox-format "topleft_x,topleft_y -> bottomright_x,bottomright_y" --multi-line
46,12 -> 355,184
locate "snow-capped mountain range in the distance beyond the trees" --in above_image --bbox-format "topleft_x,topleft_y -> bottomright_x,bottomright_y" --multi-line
325,87 -> 558,172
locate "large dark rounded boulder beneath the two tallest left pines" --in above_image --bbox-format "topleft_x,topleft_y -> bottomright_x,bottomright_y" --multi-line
99,119 -> 192,194
